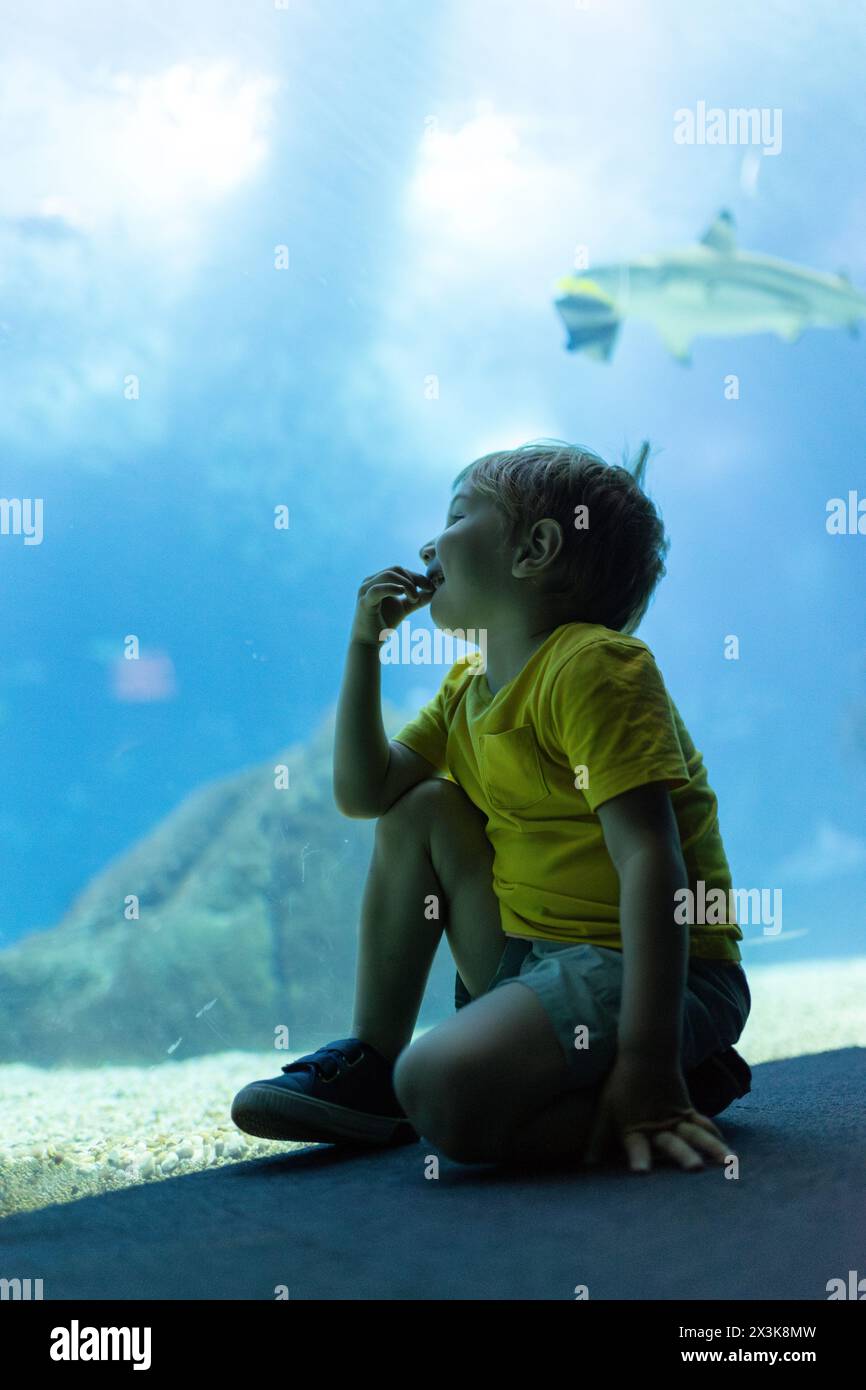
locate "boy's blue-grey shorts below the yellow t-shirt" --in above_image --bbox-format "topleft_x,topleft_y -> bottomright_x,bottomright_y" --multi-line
455,937 -> 752,1086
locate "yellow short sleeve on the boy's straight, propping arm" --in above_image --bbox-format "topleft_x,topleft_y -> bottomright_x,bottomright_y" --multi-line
549,641 -> 688,812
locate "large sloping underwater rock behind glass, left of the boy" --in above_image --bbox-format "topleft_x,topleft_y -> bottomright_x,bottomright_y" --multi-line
0,706 -> 414,1070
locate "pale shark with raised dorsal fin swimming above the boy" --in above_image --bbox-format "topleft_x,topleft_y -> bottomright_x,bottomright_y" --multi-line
553,209 -> 866,366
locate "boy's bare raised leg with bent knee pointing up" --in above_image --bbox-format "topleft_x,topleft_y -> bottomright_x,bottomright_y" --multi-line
352,778 -> 506,1061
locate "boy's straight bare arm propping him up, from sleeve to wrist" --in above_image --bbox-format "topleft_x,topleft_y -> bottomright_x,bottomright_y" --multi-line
596,781 -> 688,1068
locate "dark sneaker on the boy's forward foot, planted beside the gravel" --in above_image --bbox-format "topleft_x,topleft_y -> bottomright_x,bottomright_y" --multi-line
232,1038 -> 418,1145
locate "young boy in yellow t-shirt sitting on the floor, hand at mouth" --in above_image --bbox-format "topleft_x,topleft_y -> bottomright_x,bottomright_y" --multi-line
232,441 -> 751,1172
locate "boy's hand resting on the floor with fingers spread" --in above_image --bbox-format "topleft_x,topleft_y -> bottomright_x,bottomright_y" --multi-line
584,1056 -> 730,1173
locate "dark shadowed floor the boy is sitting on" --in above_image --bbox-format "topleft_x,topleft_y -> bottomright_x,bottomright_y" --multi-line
0,1048 -> 866,1300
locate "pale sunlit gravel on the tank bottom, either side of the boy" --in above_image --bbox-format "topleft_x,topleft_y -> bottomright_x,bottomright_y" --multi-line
0,956 -> 866,1216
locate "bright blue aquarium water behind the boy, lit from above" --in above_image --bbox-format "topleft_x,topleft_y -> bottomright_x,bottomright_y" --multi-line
0,0 -> 866,995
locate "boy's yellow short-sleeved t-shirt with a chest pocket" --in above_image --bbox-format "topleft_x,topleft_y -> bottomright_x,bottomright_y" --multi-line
395,623 -> 742,960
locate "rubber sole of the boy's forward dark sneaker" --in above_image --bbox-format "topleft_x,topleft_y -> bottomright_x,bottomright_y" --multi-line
232,1081 -> 418,1144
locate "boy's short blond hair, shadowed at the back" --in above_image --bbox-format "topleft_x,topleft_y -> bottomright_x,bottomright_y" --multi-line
453,439 -> 670,634
